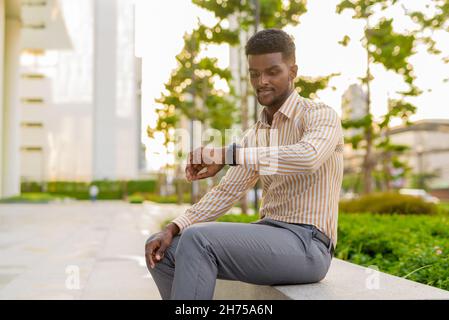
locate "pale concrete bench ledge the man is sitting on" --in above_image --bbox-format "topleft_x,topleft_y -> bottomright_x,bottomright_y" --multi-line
214,258 -> 449,300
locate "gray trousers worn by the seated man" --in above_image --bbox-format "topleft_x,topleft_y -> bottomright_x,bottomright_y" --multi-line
147,218 -> 332,300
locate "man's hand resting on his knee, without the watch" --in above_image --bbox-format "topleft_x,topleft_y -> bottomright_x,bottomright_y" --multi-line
145,223 -> 179,269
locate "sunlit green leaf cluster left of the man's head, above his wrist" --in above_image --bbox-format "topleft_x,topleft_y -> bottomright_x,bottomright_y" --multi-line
147,29 -> 236,145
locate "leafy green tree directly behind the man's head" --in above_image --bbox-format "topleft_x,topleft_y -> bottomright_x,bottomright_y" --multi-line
148,0 -> 335,208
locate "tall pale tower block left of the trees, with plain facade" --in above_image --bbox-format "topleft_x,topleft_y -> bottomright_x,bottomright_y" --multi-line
92,0 -> 141,179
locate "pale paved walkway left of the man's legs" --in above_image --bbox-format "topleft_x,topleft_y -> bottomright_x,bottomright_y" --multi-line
0,201 -> 186,299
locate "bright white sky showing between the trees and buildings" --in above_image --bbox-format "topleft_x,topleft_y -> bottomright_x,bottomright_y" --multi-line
136,0 -> 449,169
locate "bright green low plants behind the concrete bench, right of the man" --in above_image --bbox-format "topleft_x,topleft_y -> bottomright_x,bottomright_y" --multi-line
335,213 -> 449,290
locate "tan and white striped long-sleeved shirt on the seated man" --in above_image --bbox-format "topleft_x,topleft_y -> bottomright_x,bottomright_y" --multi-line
172,91 -> 344,247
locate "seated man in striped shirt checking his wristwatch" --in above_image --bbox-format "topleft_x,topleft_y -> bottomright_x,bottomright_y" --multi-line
146,29 -> 343,300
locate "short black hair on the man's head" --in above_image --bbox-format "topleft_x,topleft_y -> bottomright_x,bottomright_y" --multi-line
245,29 -> 296,62
